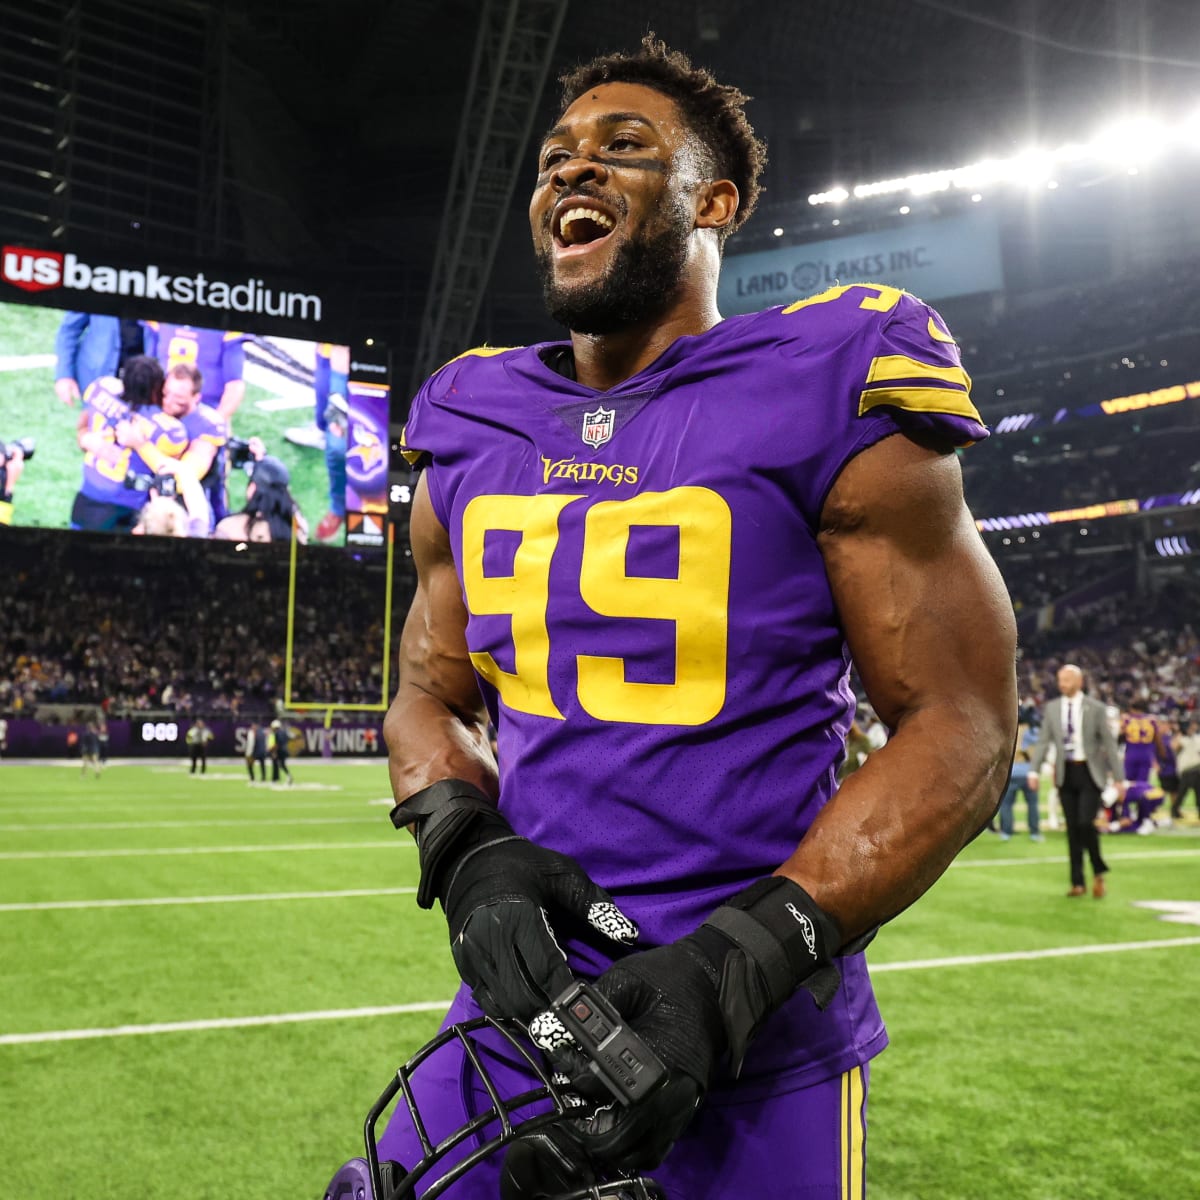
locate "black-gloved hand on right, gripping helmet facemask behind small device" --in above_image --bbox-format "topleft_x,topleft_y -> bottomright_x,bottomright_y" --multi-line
529,930 -> 727,1171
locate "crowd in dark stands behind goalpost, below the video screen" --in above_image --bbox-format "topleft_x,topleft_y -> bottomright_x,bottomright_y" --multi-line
0,534 -> 403,716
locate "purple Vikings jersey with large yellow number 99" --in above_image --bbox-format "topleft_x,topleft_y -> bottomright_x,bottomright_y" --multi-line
404,284 -> 986,1087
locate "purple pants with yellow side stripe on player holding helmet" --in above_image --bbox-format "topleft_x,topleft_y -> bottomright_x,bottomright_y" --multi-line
379,996 -> 870,1200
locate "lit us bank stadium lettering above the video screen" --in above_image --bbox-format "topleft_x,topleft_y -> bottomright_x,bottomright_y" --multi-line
0,246 -> 323,324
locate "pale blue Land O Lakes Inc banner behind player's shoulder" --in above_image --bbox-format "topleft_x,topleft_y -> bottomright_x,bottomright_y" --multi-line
718,212 -> 1004,314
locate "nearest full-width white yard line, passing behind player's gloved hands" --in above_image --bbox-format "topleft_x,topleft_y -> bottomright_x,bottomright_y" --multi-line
0,937 -> 1200,1045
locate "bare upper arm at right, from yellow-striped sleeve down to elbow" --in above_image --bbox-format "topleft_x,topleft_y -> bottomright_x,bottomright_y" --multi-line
820,434 -> 1016,731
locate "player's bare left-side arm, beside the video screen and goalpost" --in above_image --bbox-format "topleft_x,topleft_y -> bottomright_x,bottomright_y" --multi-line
383,476 -> 499,800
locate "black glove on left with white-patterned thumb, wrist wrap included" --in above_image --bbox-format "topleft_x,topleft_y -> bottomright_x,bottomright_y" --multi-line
391,779 -> 637,1021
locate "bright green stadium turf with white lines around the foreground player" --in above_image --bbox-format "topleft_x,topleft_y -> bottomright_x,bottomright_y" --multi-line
0,758 -> 1200,1200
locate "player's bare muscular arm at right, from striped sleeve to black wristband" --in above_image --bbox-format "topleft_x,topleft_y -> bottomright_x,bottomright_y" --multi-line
779,436 -> 1016,941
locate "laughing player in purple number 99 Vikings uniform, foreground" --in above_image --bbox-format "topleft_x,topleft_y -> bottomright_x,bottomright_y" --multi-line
335,38 -> 1016,1200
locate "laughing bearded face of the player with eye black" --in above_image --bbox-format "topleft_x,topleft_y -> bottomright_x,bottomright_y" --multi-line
529,83 -> 715,334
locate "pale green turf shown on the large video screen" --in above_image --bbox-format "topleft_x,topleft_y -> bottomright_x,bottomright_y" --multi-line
0,304 -> 329,530
